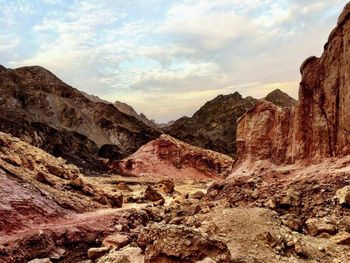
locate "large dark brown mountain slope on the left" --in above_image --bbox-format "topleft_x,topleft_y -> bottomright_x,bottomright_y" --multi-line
0,66 -> 160,172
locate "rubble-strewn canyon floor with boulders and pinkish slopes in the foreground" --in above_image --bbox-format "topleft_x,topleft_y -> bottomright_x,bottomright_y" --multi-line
0,133 -> 350,263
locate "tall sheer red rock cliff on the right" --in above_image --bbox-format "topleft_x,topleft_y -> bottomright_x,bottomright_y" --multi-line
237,4 -> 350,163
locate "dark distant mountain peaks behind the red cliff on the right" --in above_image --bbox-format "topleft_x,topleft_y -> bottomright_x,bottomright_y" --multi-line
163,90 -> 296,157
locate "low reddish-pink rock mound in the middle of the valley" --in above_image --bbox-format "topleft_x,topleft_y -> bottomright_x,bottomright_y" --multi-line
117,134 -> 233,178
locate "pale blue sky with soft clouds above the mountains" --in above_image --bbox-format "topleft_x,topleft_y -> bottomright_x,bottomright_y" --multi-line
0,0 -> 347,122
